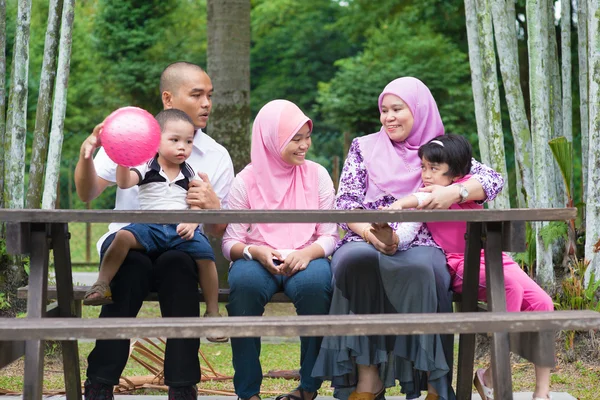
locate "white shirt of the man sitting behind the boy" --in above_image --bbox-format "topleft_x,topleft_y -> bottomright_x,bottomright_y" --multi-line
94,129 -> 234,253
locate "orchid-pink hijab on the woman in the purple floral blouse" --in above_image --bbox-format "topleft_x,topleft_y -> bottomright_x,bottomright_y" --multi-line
359,77 -> 444,202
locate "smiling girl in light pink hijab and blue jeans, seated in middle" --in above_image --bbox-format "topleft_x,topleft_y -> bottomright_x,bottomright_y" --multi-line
223,100 -> 339,400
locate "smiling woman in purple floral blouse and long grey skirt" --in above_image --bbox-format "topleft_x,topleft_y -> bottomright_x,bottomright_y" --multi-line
313,77 -> 504,400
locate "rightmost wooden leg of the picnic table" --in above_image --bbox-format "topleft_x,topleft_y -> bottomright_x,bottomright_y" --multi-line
485,222 -> 513,400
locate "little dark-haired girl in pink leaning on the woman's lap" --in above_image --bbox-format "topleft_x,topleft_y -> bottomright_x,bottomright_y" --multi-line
390,134 -> 554,400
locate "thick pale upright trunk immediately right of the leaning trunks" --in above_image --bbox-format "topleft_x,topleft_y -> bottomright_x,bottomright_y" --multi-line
526,0 -> 554,288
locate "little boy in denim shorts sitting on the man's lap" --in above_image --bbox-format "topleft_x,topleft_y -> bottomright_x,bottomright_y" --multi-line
83,109 -> 227,342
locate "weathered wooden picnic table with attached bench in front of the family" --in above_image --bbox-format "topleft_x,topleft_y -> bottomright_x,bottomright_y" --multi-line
0,208 -> 600,400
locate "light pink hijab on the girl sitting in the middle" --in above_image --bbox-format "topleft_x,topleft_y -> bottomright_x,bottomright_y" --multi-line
239,100 -> 319,249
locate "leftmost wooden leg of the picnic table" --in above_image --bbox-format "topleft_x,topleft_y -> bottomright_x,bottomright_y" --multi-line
23,224 -> 48,400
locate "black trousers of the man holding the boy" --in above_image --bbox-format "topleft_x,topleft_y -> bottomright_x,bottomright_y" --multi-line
87,231 -> 200,387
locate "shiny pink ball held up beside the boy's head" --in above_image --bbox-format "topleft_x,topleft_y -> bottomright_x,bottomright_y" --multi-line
100,107 -> 160,167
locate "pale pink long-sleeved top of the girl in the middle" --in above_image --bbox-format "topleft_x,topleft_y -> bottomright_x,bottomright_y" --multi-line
221,165 -> 339,261
